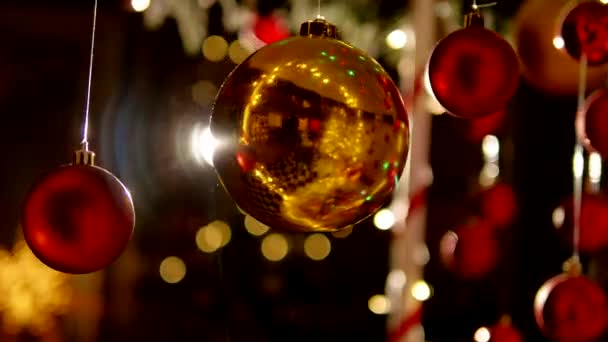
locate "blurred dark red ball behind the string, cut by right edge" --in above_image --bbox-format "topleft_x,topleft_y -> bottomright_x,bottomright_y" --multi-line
555,193 -> 608,252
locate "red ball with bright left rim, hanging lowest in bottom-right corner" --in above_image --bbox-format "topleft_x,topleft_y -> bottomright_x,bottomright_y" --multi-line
534,274 -> 608,342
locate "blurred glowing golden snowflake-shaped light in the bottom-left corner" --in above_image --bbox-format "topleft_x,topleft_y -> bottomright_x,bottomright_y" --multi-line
0,241 -> 73,335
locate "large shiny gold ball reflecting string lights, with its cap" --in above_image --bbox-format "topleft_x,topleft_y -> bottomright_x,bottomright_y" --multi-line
210,19 -> 409,231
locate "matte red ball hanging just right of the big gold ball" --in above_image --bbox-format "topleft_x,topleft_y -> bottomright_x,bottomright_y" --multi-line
429,26 -> 519,119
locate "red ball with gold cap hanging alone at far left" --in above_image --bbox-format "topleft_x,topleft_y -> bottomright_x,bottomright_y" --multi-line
21,150 -> 135,274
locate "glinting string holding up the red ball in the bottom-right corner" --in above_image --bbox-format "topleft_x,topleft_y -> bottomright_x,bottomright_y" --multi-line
572,54 -> 587,262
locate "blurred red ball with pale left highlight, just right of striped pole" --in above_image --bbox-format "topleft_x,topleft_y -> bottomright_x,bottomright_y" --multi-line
440,220 -> 499,279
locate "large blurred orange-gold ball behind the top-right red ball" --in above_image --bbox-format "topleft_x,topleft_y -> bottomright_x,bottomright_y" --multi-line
512,0 -> 608,95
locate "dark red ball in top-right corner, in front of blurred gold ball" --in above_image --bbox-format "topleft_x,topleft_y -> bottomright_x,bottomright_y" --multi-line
560,0 -> 608,66
